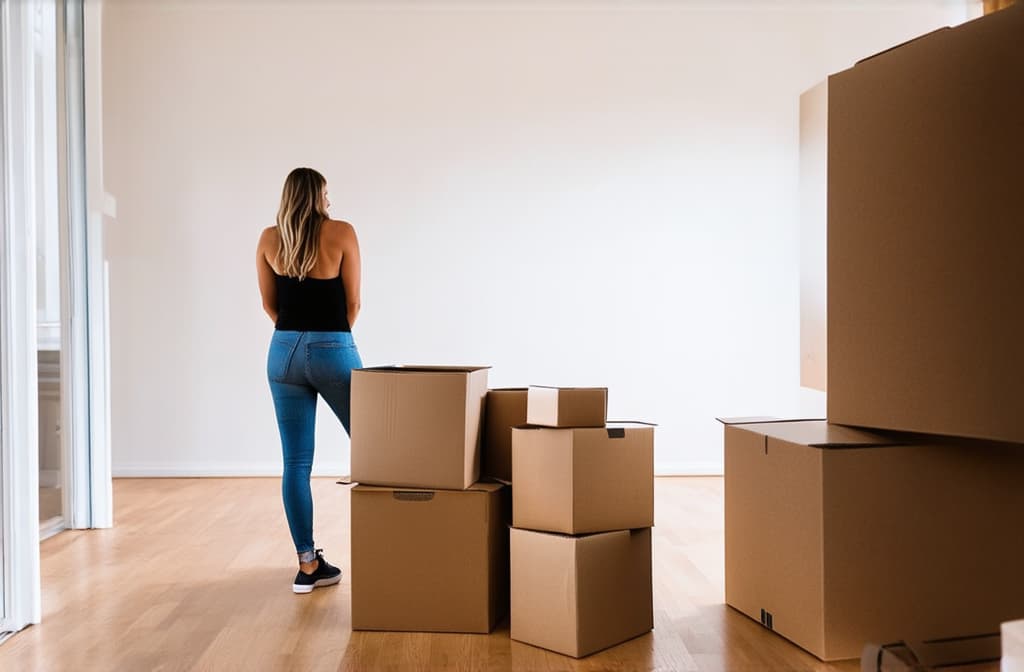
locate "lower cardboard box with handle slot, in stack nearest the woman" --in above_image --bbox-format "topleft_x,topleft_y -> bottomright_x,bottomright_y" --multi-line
351,482 -> 509,632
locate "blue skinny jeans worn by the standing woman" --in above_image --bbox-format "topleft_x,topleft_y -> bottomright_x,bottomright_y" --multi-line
266,331 -> 362,553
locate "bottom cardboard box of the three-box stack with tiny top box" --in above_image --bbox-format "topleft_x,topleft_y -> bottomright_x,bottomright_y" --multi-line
511,529 -> 654,658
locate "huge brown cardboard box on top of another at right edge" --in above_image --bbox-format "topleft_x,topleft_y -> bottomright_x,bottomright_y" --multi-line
827,2 -> 1024,443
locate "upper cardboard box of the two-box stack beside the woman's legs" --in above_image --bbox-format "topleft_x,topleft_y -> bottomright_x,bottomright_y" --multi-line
351,367 -> 487,490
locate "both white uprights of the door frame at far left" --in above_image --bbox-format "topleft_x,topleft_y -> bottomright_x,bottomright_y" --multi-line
0,0 -> 115,641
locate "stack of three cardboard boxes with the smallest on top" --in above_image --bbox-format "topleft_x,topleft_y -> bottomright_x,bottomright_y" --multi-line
511,387 -> 654,658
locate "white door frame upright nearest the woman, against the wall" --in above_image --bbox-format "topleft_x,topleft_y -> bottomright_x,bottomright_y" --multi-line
58,0 -> 115,530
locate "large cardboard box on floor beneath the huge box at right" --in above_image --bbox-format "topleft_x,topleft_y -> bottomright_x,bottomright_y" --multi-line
725,421 -> 1024,661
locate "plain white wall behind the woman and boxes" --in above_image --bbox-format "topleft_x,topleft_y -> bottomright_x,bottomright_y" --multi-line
103,0 -> 967,475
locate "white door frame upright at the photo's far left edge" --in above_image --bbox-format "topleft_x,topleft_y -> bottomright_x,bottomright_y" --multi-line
0,0 -> 42,632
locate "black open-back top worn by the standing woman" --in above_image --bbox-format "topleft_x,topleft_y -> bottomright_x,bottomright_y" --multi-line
274,274 -> 351,331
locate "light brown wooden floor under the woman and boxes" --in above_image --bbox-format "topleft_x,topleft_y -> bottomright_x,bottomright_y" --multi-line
0,477 -> 997,672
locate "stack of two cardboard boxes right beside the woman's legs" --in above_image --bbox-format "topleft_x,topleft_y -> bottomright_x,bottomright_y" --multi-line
351,367 -> 509,633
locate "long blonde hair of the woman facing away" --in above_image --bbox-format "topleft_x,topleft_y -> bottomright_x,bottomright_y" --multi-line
278,168 -> 329,280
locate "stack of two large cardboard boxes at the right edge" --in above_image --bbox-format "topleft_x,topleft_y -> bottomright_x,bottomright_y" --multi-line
725,6 -> 1024,660
